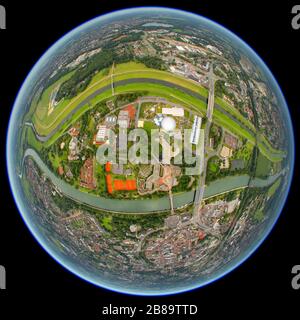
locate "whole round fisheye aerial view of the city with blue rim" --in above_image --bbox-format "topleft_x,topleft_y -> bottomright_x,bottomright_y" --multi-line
7,7 -> 294,295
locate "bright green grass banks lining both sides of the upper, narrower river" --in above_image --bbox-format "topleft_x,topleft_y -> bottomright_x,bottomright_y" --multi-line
28,62 -> 284,162
